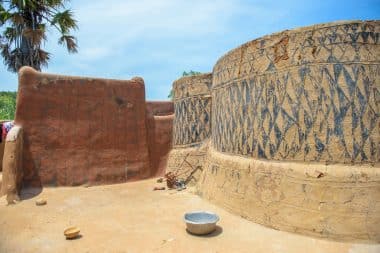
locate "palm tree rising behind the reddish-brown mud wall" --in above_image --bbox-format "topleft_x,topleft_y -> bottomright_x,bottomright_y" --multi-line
0,0 -> 77,72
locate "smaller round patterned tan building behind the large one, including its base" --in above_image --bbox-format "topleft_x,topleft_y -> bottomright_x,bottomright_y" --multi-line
166,73 -> 212,184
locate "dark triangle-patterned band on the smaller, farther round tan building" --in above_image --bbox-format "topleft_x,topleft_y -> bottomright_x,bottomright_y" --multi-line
173,96 -> 211,146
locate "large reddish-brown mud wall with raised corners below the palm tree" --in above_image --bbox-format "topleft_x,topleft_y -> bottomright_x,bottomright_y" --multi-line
15,68 -> 150,185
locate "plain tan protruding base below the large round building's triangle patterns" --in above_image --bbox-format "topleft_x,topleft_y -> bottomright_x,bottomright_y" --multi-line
197,148 -> 380,242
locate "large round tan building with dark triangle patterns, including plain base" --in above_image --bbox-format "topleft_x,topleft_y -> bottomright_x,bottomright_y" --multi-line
194,21 -> 380,242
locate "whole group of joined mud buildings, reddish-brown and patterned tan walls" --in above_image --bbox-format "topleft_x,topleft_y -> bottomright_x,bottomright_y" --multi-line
2,21 -> 380,243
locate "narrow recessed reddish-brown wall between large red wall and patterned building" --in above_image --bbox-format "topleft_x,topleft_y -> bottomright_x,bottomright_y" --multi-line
146,101 -> 174,176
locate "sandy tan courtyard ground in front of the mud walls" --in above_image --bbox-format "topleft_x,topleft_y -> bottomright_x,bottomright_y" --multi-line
0,180 -> 380,253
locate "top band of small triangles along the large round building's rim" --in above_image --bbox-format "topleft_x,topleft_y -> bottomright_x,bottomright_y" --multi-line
212,21 -> 380,88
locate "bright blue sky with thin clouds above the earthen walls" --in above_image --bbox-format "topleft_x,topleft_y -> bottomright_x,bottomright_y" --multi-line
0,0 -> 380,100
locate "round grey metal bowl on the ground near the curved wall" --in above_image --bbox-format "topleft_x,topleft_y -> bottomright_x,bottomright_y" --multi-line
184,211 -> 219,235
